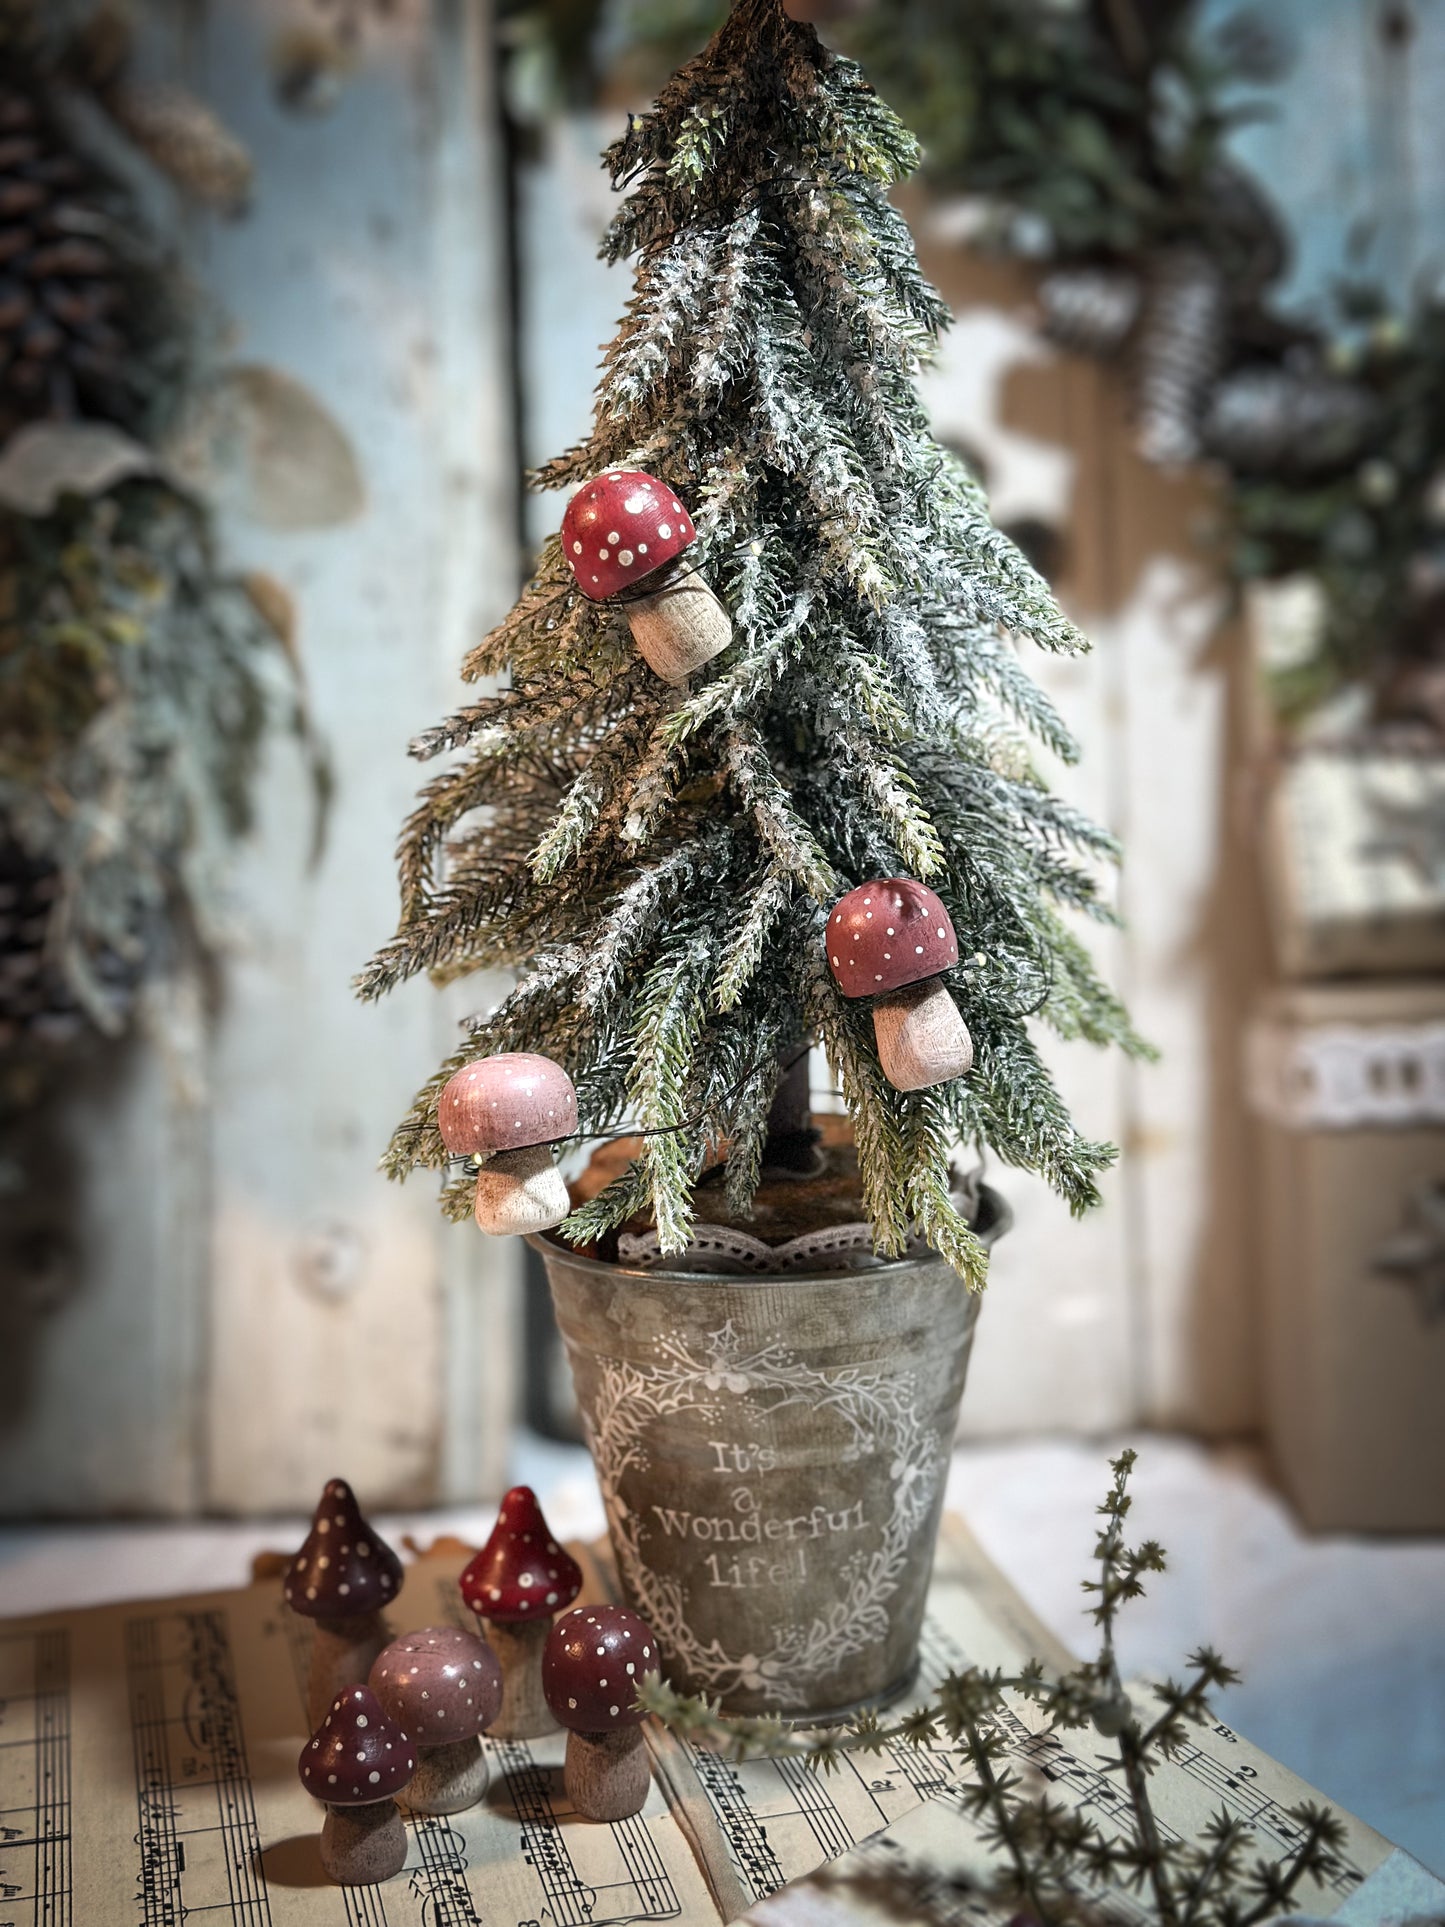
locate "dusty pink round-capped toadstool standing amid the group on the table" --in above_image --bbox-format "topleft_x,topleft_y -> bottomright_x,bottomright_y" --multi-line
368,1626 -> 501,1813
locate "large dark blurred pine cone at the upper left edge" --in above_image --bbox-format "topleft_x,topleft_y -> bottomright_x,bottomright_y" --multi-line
0,87 -> 127,436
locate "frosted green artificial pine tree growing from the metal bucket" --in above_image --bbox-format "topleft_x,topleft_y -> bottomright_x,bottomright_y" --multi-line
360,0 -> 1137,1283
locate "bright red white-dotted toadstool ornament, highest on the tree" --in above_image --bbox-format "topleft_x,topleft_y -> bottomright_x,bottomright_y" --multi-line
563,468 -> 732,682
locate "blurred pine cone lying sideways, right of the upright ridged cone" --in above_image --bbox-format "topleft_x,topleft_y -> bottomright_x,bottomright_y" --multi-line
1202,368 -> 1378,476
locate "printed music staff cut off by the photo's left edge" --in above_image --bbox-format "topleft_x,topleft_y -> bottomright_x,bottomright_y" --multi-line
0,1632 -> 73,1927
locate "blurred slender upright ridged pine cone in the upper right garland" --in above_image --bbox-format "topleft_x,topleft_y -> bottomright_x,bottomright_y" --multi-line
1135,247 -> 1229,466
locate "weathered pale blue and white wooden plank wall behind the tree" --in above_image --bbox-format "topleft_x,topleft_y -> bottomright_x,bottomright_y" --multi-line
0,0 -> 1445,1515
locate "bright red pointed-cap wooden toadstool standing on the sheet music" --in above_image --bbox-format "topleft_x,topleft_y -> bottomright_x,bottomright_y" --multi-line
460,1486 -> 582,1740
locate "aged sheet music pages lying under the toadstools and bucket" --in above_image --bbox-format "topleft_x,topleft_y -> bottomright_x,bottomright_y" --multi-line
0,1520 -> 1425,1927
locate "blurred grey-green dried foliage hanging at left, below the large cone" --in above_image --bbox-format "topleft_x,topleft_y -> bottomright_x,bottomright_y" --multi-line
0,480 -> 315,1048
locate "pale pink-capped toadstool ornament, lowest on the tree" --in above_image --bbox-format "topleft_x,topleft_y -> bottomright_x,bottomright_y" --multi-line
437,1050 -> 576,1237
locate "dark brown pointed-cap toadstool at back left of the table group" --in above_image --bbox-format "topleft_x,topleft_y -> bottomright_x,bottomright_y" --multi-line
281,1478 -> 401,1727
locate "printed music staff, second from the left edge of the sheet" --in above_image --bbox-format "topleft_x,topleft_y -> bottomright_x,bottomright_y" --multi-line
125,1611 -> 272,1927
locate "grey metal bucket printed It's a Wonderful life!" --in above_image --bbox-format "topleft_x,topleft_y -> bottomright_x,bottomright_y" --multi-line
532,1185 -> 1012,1721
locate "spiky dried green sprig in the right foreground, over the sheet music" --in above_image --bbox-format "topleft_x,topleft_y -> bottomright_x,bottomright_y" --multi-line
638,1451 -> 1343,1927
